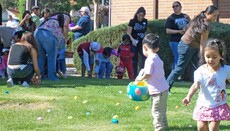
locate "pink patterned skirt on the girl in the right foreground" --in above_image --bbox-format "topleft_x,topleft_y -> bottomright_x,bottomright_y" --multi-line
193,104 -> 230,121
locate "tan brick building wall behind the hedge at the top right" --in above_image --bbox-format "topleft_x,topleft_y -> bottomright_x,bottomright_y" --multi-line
110,0 -> 230,26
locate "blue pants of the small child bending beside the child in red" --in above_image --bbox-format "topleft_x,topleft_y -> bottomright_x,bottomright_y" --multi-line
98,62 -> 113,79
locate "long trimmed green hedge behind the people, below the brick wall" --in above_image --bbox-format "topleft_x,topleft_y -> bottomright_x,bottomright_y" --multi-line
73,20 -> 230,77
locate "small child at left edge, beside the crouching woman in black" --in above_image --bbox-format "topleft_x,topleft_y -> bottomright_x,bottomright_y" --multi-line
0,48 -> 9,79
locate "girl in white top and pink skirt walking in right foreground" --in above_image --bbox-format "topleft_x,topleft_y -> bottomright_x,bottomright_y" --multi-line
182,39 -> 230,131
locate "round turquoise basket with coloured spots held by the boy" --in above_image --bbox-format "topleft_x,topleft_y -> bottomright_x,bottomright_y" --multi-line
127,81 -> 150,101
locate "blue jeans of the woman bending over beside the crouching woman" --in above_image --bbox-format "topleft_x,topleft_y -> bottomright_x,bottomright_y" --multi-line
34,29 -> 58,81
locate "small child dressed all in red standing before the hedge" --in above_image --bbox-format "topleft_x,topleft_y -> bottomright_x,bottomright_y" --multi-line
116,34 -> 134,79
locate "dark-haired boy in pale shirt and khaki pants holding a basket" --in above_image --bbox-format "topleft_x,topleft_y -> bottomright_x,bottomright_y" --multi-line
136,34 -> 169,131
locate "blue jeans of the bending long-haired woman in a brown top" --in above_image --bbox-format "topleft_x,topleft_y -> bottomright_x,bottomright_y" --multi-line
167,41 -> 199,89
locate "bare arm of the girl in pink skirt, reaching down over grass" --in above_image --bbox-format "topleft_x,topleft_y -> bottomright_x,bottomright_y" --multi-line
182,81 -> 200,106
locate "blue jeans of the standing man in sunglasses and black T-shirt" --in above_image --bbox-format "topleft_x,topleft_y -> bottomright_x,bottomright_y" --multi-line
169,41 -> 179,69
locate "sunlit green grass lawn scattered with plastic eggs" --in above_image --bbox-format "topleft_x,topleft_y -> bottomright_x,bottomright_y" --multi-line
0,77 -> 230,131
